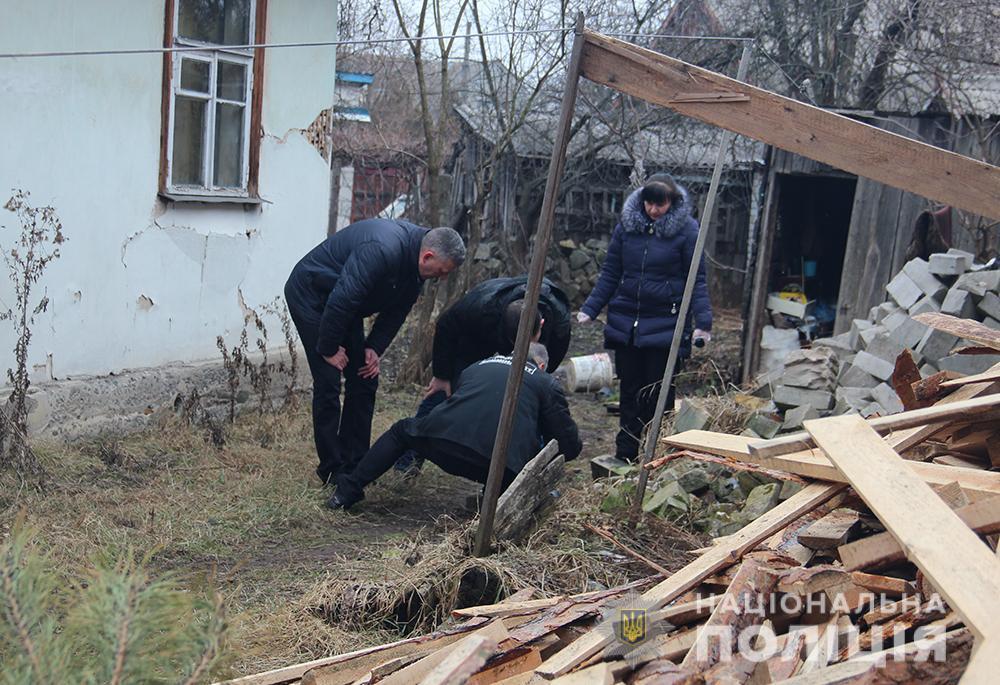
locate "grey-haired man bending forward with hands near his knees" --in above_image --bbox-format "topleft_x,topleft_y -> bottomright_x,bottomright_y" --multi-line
285,219 -> 465,483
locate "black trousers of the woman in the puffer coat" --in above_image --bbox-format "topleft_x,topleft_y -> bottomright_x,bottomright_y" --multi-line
615,345 -> 681,461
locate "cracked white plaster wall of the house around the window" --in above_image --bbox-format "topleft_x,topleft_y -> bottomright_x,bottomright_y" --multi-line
0,0 -> 337,378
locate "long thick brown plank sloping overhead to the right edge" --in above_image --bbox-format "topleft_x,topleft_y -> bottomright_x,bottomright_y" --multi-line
580,32 -> 1000,218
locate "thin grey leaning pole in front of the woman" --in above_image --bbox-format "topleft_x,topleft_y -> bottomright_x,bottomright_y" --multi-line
631,42 -> 752,524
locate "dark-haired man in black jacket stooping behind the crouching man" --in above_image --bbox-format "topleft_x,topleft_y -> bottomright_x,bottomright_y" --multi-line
396,276 -> 570,476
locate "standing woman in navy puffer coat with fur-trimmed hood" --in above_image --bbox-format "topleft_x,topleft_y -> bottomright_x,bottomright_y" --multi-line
577,174 -> 712,461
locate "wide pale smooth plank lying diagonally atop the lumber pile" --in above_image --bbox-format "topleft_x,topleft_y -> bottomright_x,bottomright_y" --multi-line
805,416 -> 1000,642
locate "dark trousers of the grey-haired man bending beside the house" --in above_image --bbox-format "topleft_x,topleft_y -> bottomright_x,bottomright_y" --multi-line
289,302 -> 378,483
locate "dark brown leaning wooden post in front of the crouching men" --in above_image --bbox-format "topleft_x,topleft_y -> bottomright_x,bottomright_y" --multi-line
474,13 -> 585,557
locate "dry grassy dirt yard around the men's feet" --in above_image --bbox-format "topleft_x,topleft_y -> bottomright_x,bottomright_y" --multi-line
0,312 -> 738,677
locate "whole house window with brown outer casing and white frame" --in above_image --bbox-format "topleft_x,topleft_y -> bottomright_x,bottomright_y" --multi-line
161,0 -> 265,199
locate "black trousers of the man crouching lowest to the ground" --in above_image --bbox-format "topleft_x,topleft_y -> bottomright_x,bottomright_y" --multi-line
337,418 -> 516,503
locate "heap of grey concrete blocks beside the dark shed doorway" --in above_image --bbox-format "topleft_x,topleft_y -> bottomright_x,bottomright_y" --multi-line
761,249 -> 1000,437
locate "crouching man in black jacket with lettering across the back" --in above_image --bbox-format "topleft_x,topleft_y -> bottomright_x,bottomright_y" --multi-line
327,343 -> 583,509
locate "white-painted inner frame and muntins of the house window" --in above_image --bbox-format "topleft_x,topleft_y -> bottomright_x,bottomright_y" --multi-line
166,0 -> 257,199
